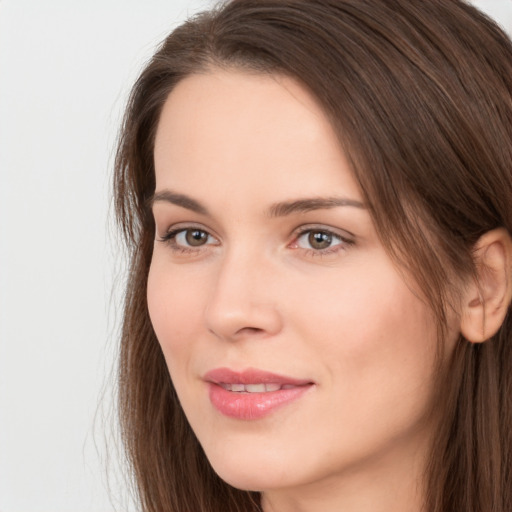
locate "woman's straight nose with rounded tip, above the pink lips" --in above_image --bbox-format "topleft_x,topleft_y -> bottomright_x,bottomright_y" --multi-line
205,249 -> 282,341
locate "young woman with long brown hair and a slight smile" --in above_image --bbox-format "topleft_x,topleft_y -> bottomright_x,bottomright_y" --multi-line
115,0 -> 512,512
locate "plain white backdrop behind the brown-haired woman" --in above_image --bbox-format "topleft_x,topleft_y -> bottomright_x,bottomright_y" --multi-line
0,0 -> 512,512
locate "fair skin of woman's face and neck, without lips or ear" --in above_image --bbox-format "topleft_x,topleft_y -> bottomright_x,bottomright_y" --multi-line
148,69 -> 458,512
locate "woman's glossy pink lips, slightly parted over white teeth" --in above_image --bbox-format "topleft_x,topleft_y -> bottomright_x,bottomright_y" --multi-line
203,368 -> 313,420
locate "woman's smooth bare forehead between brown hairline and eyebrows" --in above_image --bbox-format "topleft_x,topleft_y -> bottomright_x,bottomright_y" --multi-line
155,70 -> 359,204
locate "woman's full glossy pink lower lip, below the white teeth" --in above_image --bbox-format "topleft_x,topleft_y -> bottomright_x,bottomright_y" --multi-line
209,383 -> 313,420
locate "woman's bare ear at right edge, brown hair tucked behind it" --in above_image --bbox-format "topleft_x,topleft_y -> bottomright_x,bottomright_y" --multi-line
461,228 -> 512,343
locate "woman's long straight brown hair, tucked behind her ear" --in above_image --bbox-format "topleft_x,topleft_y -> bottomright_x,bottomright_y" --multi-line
114,0 -> 512,512
